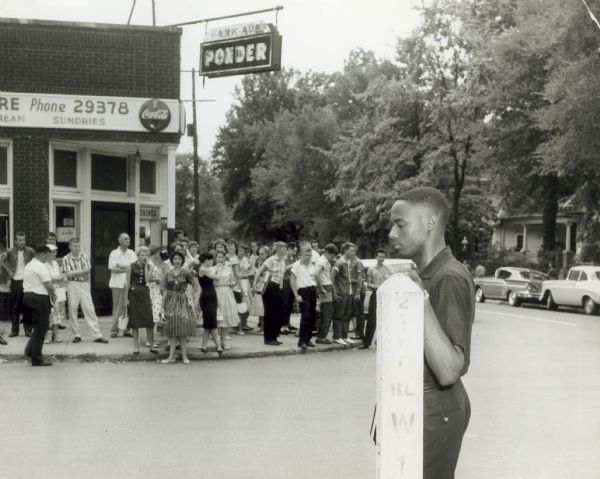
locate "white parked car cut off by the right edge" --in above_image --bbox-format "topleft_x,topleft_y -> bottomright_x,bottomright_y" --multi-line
540,265 -> 600,314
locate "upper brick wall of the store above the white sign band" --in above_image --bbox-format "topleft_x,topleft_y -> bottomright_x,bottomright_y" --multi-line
0,19 -> 181,98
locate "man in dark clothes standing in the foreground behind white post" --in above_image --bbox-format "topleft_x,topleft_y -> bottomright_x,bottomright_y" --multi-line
389,188 -> 475,479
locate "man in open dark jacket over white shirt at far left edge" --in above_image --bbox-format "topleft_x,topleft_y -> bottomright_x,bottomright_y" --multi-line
1,231 -> 35,338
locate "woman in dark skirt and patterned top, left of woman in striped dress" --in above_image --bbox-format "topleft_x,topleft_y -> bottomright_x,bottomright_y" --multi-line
125,246 -> 158,355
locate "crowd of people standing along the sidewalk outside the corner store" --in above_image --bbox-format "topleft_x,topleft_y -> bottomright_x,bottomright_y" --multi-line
0,232 -> 391,365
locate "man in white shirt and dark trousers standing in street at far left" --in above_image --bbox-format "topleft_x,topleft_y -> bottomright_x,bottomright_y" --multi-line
23,245 -> 56,366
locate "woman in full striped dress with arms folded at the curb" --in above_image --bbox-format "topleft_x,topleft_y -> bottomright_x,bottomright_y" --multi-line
162,251 -> 196,364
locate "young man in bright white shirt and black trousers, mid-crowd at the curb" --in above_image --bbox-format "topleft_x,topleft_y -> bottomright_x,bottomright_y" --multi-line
290,241 -> 317,349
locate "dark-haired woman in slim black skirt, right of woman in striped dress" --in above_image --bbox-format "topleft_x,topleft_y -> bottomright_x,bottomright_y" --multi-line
198,253 -> 223,356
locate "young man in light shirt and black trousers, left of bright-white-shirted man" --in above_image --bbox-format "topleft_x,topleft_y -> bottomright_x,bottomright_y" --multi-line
253,241 -> 286,346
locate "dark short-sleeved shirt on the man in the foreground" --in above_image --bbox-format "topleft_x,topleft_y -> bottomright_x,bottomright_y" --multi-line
420,246 -> 475,391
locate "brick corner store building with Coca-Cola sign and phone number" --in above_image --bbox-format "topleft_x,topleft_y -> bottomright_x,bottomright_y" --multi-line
0,18 -> 183,305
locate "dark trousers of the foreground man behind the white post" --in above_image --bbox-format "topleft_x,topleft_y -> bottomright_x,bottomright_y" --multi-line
423,380 -> 471,479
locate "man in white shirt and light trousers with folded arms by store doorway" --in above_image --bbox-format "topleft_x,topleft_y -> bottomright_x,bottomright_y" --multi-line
108,233 -> 137,338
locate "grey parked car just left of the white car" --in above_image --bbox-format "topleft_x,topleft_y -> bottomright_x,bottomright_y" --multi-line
474,267 -> 548,306
